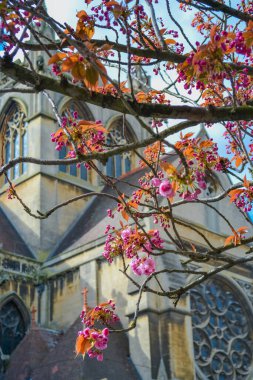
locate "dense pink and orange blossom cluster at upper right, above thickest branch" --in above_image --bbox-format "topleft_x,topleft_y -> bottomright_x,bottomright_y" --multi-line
177,21 -> 253,96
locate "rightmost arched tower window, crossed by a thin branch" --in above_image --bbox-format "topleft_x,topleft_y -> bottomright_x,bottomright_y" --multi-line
106,117 -> 134,177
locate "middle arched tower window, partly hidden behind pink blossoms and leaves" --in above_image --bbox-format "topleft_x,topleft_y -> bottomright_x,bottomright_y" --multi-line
59,100 -> 93,181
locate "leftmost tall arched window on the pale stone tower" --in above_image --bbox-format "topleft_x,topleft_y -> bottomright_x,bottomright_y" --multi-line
0,101 -> 28,179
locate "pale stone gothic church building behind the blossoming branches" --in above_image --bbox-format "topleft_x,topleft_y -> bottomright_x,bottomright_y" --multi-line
0,14 -> 253,380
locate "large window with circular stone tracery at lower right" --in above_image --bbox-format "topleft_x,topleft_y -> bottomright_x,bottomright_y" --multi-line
190,278 -> 253,380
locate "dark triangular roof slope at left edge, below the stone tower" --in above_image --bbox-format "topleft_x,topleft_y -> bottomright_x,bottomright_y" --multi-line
0,208 -> 34,258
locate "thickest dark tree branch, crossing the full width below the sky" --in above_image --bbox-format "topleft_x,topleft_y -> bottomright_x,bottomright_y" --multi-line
0,58 -> 253,123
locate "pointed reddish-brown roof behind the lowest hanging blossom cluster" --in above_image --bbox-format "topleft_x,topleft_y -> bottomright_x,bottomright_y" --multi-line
32,317 -> 139,380
